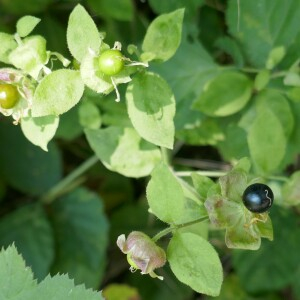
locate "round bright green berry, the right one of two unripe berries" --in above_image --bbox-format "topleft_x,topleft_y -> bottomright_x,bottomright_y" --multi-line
98,49 -> 124,76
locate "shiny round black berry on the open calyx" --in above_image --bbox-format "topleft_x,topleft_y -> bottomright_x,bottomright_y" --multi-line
243,183 -> 274,213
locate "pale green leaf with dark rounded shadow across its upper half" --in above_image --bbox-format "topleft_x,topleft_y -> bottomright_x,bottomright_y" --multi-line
126,73 -> 175,149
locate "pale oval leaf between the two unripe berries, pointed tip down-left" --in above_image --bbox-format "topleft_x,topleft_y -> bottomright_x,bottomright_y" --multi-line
32,69 -> 84,117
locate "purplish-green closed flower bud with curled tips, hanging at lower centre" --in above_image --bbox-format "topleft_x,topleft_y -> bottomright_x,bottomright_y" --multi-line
117,231 -> 166,280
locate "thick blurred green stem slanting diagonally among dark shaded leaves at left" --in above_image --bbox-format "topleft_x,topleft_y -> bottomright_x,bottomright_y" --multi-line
41,155 -> 99,204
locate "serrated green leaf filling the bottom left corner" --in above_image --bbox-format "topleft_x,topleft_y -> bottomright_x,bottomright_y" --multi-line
0,245 -> 36,300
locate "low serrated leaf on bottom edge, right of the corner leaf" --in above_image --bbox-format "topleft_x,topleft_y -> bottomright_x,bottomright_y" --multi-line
16,275 -> 104,300
